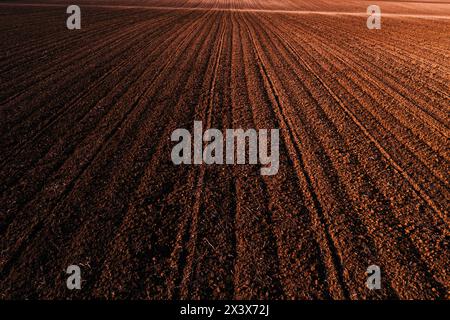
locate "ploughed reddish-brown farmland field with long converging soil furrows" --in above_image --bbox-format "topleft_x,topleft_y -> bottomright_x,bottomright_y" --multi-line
0,0 -> 450,299
